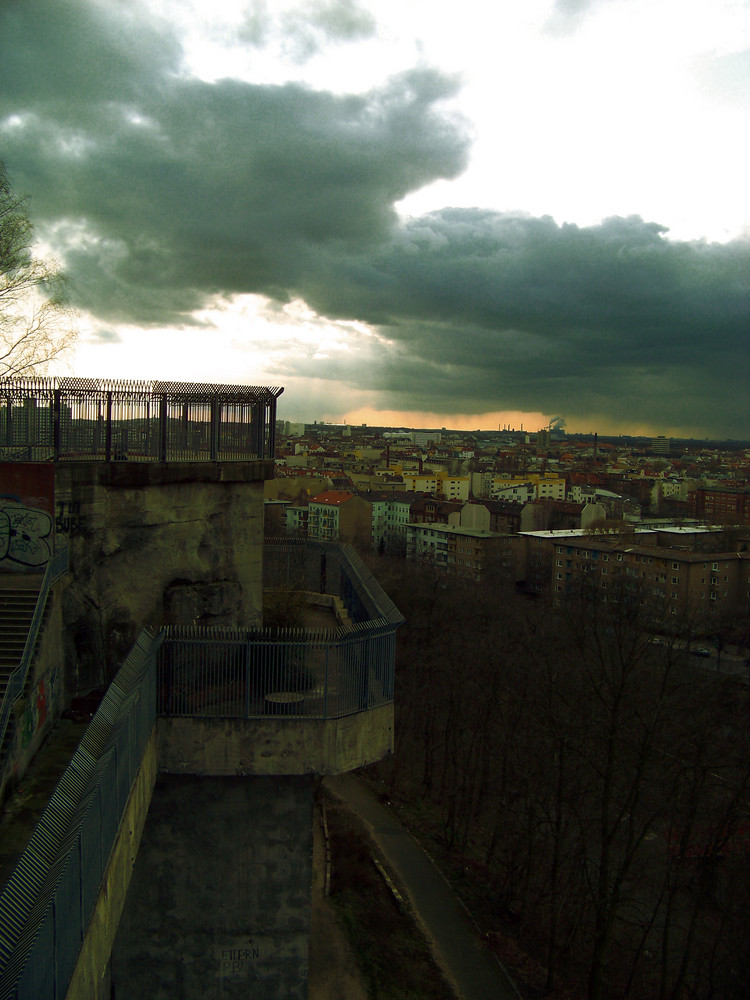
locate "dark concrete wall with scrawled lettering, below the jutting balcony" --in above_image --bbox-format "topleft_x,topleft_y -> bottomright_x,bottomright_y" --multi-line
112,775 -> 313,1000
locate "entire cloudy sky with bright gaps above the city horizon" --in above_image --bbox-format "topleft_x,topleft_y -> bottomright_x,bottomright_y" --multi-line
0,0 -> 750,439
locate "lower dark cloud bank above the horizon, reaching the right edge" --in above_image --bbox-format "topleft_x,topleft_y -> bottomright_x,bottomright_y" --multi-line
292,209 -> 750,436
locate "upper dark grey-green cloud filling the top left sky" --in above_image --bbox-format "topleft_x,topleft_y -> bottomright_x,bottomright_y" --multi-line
0,2 -> 466,323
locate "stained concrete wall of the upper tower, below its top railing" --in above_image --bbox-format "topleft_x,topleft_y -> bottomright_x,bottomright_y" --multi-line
55,461 -> 273,692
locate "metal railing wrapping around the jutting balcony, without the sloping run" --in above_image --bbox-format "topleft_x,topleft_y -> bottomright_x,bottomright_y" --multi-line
157,539 -> 404,719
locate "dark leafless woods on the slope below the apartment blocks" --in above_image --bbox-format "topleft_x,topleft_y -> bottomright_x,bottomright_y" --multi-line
370,561 -> 750,1000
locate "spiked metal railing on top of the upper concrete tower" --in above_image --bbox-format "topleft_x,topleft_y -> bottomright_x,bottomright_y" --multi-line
0,378 -> 284,462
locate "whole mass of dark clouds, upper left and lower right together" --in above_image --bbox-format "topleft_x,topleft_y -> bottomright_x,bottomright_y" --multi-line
0,0 -> 750,437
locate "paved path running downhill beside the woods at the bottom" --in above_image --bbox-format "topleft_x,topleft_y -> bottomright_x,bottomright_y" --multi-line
324,774 -> 519,1000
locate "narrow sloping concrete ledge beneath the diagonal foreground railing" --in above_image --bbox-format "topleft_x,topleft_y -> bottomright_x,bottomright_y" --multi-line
66,731 -> 157,1000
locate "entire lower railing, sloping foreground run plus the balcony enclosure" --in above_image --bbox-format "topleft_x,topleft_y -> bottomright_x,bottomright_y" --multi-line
0,542 -> 404,1000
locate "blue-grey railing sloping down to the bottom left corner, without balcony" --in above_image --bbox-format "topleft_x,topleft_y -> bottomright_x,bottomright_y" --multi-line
0,629 -> 161,1000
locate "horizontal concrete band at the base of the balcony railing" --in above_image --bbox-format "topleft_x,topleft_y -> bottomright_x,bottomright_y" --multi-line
157,704 -> 393,775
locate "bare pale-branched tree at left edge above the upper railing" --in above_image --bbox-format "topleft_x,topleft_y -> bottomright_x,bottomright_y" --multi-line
0,160 -> 77,379
